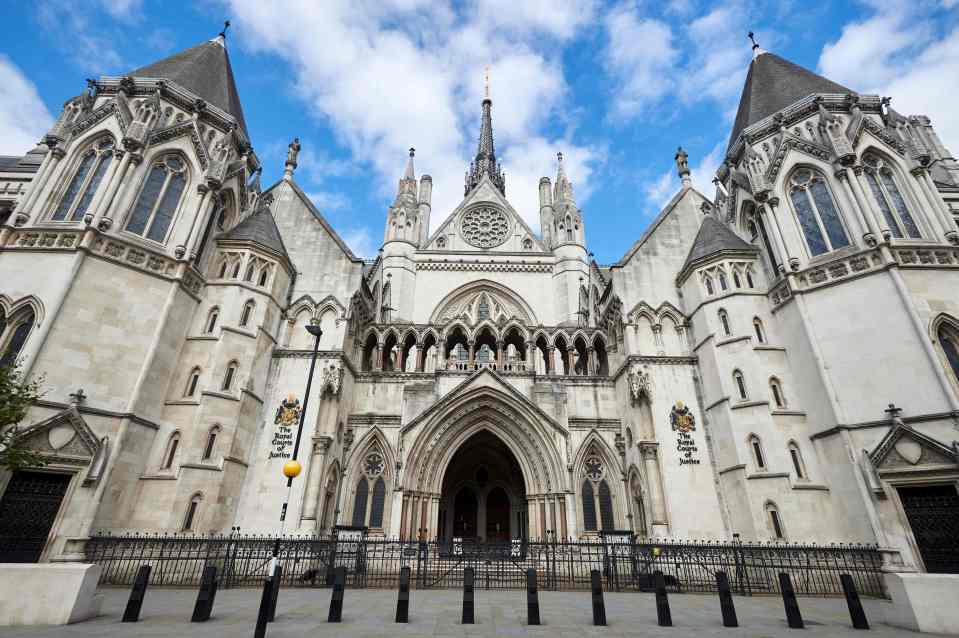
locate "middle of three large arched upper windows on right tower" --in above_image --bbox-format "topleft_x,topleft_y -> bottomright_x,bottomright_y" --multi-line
789,168 -> 849,256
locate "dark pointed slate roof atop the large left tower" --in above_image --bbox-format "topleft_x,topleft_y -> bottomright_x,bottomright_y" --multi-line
127,38 -> 249,137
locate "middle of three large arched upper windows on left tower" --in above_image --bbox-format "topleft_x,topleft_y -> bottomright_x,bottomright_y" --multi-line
127,155 -> 186,242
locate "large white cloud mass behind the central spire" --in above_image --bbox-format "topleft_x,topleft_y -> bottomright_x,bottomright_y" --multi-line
229,0 -> 596,238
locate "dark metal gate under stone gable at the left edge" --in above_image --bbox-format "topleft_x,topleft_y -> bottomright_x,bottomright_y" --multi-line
0,470 -> 72,563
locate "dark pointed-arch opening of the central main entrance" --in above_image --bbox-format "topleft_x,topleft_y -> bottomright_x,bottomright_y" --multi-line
439,430 -> 529,541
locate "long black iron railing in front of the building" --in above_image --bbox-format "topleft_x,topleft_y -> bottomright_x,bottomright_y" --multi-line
86,534 -> 885,597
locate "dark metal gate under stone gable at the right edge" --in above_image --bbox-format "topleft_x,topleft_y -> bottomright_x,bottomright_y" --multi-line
898,485 -> 959,574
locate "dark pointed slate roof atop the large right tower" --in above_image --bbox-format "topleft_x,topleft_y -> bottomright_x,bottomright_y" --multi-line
726,52 -> 855,150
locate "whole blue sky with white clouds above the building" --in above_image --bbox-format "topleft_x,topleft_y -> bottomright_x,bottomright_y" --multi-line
0,0 -> 959,263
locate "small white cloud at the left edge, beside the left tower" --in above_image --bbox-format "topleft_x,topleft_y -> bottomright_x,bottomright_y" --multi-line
0,54 -> 53,155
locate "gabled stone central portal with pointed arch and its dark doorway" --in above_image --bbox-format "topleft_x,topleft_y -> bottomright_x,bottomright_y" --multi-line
398,378 -> 575,539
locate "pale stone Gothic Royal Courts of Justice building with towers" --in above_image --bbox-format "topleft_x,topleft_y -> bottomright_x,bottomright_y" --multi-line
0,37 -> 959,571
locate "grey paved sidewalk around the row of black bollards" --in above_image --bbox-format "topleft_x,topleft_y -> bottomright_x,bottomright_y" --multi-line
0,589 -> 948,638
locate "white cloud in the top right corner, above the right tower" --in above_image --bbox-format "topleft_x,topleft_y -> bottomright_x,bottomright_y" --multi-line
819,3 -> 959,149
